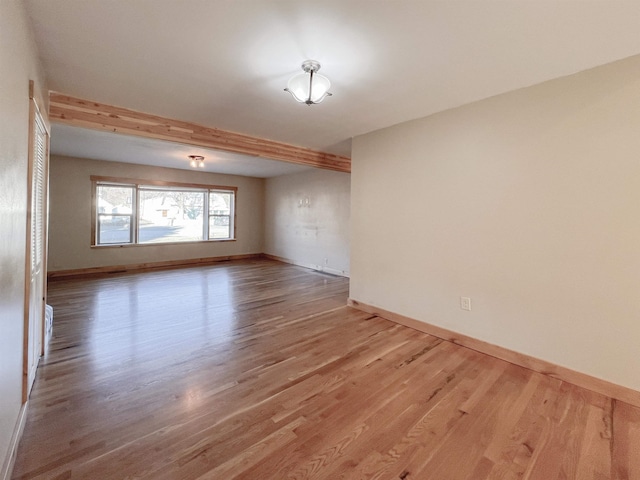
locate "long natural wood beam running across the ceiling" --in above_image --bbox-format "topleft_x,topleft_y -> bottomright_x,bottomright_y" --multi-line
49,92 -> 351,172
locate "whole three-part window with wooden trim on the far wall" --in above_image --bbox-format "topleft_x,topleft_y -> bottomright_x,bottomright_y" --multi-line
91,177 -> 236,246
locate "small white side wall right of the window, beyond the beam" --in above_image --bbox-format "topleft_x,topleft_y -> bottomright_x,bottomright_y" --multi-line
264,170 -> 351,276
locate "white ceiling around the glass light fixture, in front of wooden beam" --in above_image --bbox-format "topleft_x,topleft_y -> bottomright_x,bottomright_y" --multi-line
25,0 -> 640,176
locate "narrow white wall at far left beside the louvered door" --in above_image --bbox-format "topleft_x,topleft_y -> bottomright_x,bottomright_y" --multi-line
0,0 -> 46,478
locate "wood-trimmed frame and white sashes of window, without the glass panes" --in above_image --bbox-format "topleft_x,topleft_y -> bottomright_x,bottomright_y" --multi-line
90,175 -> 238,248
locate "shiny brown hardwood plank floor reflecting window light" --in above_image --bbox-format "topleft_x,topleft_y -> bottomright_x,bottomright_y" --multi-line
13,260 -> 640,480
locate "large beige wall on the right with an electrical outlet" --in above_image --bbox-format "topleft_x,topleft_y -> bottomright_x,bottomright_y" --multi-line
351,57 -> 640,390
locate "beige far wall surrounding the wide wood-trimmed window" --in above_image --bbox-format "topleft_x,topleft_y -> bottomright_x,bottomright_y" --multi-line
49,156 -> 264,272
